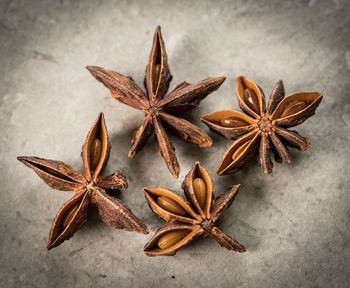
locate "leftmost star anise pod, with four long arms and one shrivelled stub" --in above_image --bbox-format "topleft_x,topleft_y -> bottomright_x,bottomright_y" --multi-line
17,113 -> 148,249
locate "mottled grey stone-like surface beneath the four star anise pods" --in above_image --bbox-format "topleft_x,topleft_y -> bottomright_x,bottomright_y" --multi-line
0,0 -> 350,287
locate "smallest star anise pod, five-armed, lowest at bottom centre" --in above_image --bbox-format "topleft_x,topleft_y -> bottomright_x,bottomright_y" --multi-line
144,162 -> 245,256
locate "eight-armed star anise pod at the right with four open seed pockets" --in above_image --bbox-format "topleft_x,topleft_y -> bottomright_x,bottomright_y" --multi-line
202,76 -> 322,175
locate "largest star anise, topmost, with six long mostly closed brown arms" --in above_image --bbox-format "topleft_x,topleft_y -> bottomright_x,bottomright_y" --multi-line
86,26 -> 225,177
